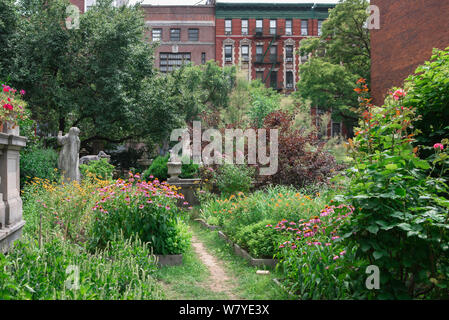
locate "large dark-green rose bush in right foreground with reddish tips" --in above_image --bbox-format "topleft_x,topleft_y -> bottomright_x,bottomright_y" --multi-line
337,80 -> 449,299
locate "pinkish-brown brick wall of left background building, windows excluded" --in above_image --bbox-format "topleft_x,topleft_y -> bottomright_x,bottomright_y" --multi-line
142,5 -> 215,67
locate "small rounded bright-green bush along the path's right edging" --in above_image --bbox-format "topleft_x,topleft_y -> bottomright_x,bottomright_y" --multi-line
233,220 -> 281,259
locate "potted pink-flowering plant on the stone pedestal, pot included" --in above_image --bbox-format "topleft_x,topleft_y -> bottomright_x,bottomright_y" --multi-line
0,84 -> 27,135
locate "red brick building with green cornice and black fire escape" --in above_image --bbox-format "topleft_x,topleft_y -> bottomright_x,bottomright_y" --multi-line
215,1 -> 335,91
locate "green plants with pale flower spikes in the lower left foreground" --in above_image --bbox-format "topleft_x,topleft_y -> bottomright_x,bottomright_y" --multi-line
0,232 -> 163,300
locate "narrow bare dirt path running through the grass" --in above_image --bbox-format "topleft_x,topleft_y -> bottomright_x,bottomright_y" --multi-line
192,235 -> 239,300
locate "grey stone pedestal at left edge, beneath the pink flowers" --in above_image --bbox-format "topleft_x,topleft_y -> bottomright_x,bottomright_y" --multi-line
0,127 -> 26,252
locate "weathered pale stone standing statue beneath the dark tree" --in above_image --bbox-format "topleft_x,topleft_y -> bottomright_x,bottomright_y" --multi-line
58,127 -> 80,182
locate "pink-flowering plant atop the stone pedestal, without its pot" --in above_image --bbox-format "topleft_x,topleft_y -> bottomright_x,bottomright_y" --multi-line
0,84 -> 28,125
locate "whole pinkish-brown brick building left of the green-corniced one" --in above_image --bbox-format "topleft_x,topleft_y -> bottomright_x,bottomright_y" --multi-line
142,5 -> 215,72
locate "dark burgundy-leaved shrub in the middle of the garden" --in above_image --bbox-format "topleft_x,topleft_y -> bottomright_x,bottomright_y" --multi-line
263,111 -> 340,187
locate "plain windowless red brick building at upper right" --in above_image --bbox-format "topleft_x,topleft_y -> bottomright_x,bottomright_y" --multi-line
371,0 -> 449,105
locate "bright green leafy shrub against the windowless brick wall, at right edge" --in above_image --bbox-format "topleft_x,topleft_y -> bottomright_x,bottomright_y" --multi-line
404,48 -> 449,150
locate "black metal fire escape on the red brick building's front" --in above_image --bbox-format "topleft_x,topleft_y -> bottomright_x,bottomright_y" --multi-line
253,24 -> 283,90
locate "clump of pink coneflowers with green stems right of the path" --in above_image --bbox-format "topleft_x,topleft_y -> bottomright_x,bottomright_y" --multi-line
267,205 -> 355,299
